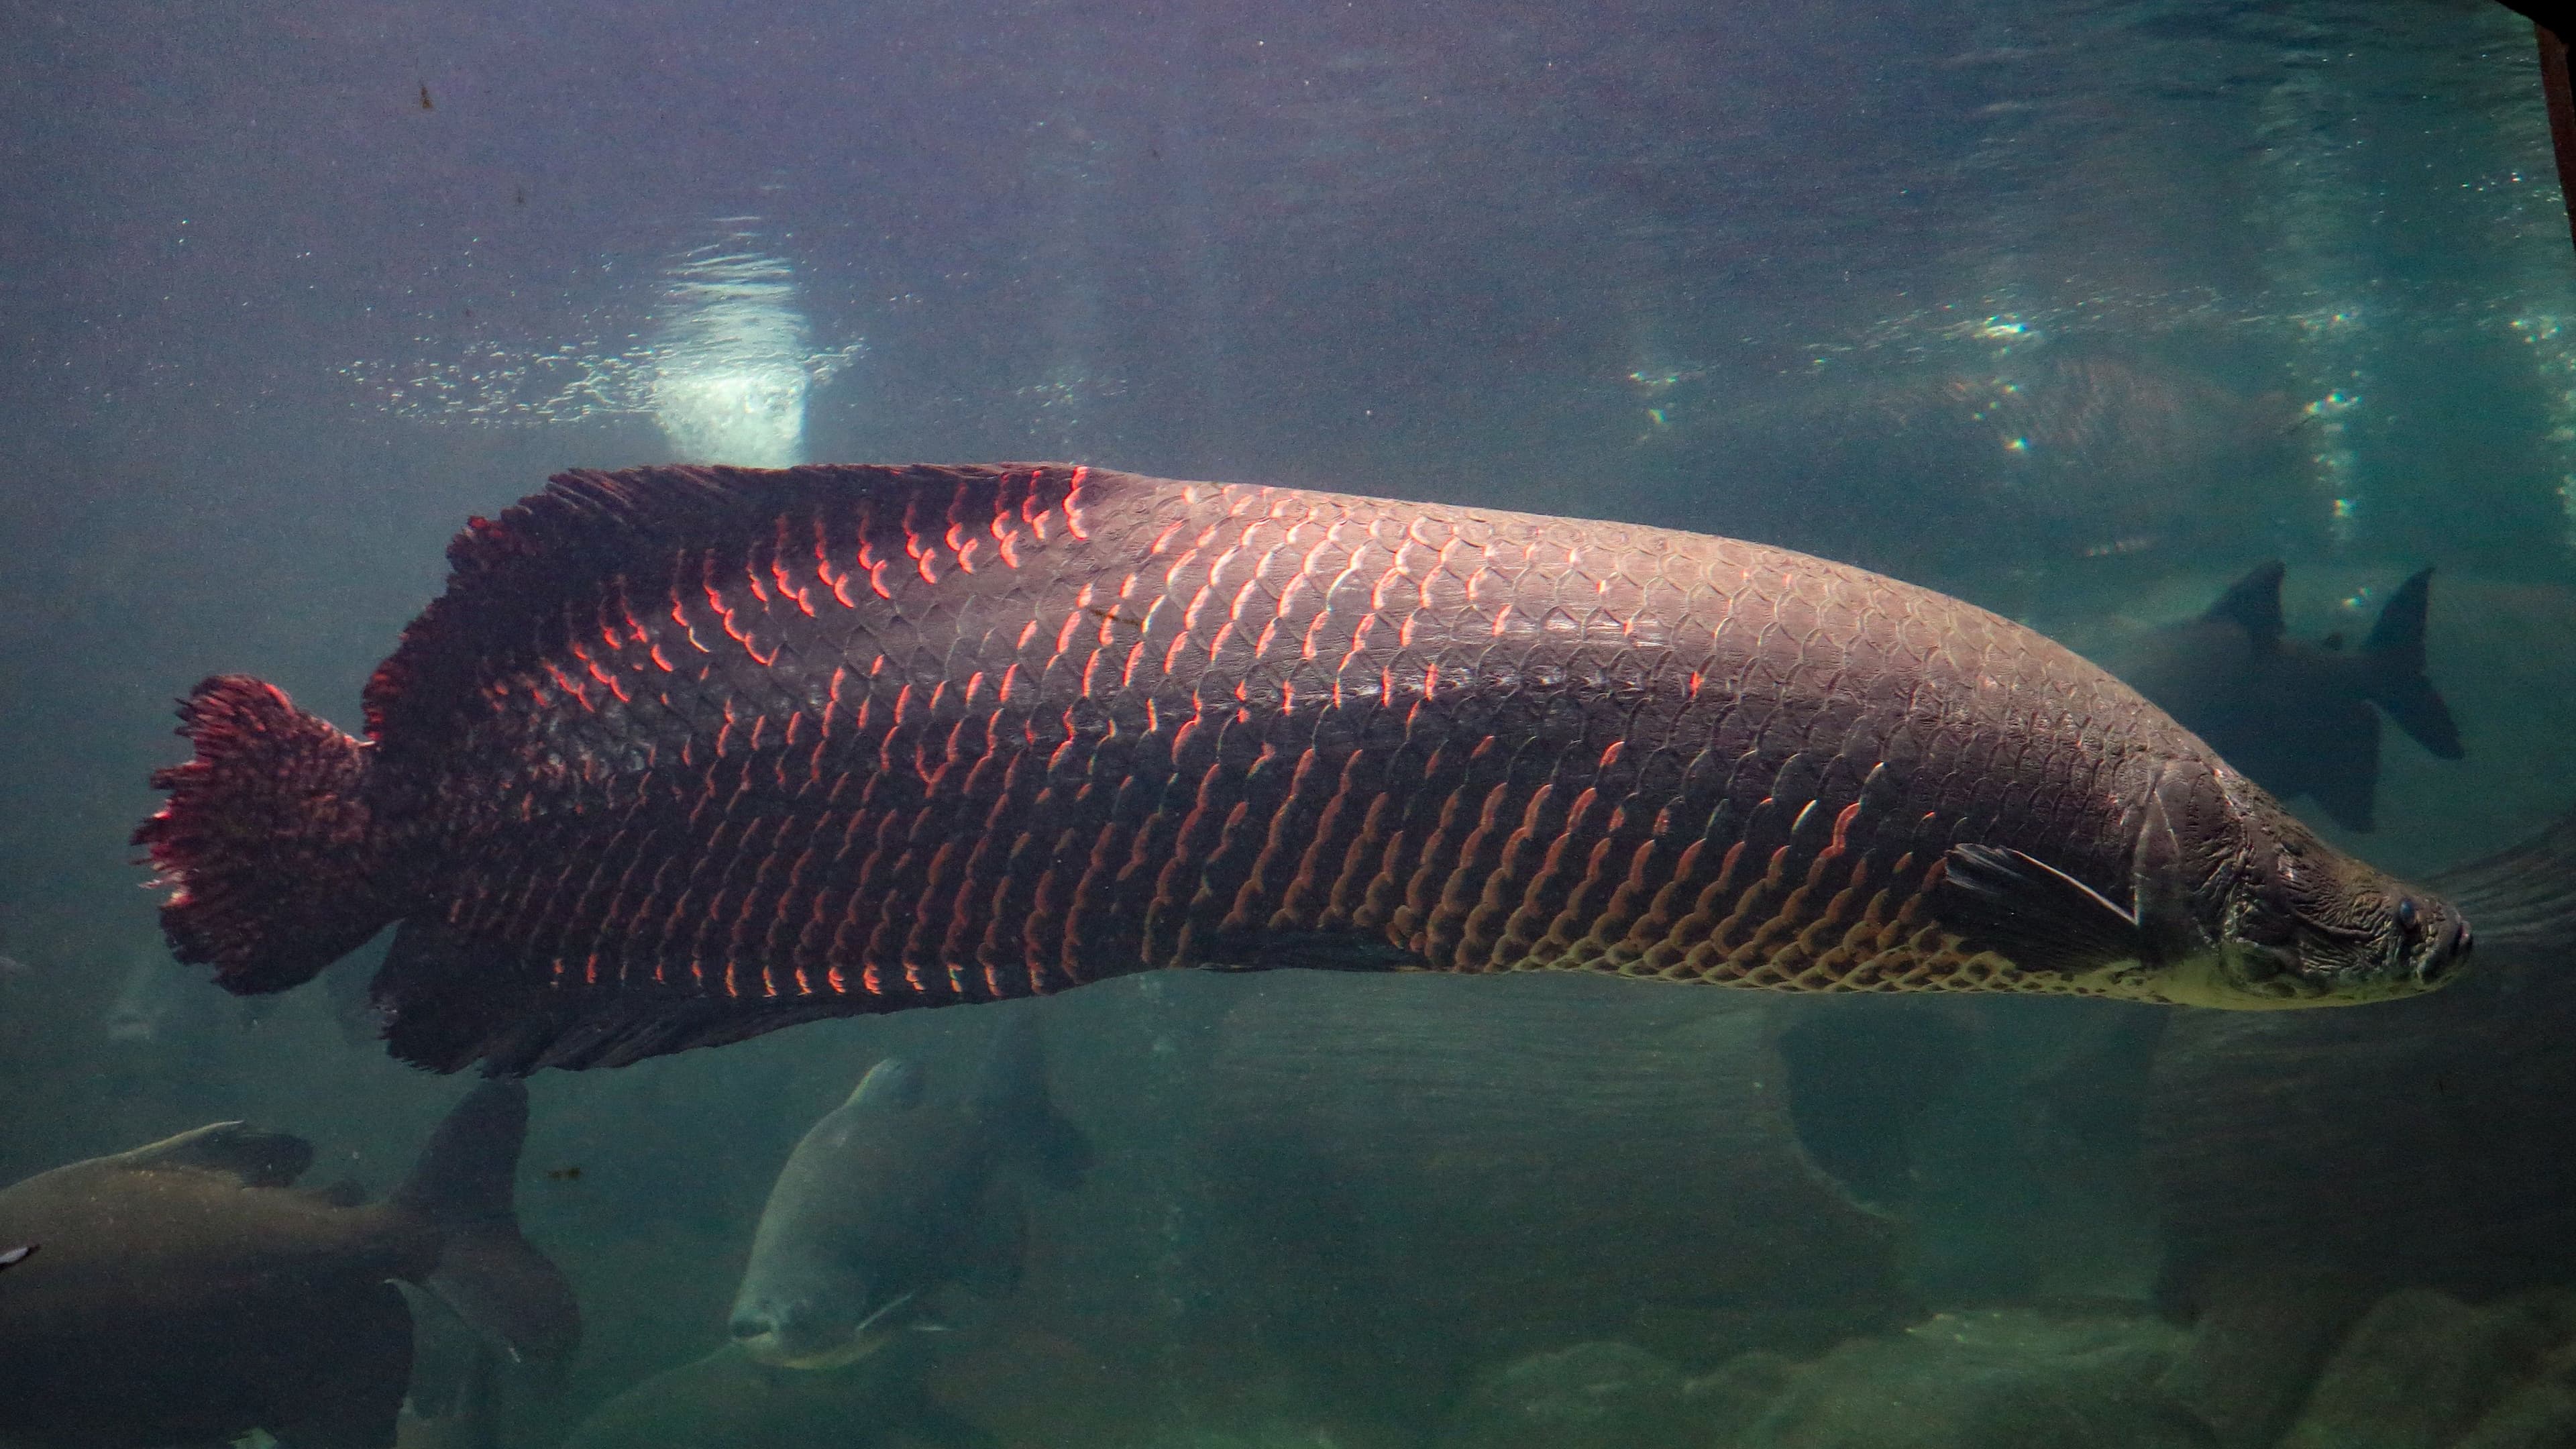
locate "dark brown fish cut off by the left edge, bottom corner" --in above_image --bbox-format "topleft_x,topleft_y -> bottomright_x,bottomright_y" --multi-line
0,1083 -> 580,1449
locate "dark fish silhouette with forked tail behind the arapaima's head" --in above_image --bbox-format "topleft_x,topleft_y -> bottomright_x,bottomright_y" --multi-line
2112,562 -> 2463,830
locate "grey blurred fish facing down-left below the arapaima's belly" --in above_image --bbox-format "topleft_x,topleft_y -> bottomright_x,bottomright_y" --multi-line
734,1013 -> 1092,1369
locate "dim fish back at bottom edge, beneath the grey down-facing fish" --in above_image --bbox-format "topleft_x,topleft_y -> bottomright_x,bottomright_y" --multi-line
564,1343 -> 1000,1449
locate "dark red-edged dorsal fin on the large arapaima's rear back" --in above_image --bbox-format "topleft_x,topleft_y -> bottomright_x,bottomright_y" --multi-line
366,464 -> 1128,750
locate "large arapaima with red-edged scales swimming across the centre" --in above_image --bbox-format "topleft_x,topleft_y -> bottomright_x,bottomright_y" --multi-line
137,464 -> 2468,1073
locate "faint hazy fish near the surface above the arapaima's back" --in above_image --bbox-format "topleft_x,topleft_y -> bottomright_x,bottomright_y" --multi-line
1641,343 -> 2316,572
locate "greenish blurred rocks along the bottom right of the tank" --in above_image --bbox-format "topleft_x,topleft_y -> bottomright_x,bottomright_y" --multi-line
1435,1271 -> 2576,1449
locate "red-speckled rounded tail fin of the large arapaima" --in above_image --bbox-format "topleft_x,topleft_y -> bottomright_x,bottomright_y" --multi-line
134,676 -> 394,993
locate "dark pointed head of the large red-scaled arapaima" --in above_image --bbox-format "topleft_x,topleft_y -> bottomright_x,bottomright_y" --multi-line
2213,773 -> 2473,1006
